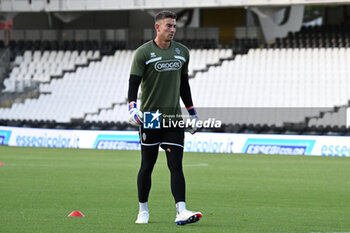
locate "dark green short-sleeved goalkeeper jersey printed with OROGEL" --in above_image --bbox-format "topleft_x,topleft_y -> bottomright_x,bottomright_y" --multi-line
131,40 -> 190,116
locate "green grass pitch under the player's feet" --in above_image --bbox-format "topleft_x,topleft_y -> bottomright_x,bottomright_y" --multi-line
0,146 -> 350,233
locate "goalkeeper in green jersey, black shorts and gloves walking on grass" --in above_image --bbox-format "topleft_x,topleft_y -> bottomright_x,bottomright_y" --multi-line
128,11 -> 202,225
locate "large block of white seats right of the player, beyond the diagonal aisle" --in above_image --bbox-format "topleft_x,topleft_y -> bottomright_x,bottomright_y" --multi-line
191,48 -> 350,107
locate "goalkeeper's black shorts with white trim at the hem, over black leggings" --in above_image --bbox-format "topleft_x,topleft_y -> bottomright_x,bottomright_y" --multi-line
139,126 -> 185,148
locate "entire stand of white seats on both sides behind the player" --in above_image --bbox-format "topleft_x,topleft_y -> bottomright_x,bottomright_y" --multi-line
0,48 -> 350,126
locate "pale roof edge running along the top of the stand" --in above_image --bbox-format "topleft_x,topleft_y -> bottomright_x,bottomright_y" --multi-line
0,0 -> 350,12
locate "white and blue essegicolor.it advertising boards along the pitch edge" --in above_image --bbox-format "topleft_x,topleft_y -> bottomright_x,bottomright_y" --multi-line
0,126 -> 350,157
